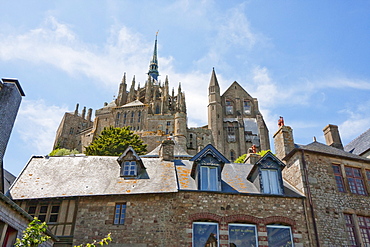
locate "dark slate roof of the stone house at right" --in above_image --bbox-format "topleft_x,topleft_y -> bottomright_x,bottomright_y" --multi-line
284,142 -> 370,162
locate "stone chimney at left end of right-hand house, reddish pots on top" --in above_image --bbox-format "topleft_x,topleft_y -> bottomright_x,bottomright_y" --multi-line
274,125 -> 294,160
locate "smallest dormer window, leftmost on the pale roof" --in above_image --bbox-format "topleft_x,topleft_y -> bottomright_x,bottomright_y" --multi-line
117,147 -> 147,179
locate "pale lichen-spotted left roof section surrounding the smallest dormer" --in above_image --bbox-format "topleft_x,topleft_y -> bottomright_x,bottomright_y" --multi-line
10,156 -> 178,200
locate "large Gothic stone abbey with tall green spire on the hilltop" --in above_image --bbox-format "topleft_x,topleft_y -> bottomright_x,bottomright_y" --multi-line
54,37 -> 270,160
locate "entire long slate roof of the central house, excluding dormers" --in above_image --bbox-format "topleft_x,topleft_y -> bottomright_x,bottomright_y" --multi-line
10,153 -> 303,200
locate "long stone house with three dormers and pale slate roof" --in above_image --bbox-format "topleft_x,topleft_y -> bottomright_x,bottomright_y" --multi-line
10,139 -> 310,247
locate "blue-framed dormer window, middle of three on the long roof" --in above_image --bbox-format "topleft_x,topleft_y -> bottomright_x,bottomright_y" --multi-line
190,144 -> 230,191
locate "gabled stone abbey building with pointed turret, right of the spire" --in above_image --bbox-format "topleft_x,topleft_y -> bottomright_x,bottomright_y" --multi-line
208,70 -> 270,161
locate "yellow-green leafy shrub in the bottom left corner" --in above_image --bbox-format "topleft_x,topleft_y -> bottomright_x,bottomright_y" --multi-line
14,217 -> 50,247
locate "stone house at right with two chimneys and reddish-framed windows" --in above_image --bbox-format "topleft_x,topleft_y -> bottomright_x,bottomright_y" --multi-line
274,125 -> 370,246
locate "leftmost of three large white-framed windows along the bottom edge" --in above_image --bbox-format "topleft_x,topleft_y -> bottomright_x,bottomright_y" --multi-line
193,222 -> 218,247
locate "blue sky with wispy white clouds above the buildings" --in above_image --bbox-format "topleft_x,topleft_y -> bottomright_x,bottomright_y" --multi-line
0,0 -> 370,175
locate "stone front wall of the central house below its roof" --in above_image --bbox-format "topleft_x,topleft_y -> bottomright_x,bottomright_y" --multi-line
73,192 -> 309,247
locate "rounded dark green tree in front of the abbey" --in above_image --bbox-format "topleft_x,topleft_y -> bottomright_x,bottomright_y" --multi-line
85,127 -> 146,156
